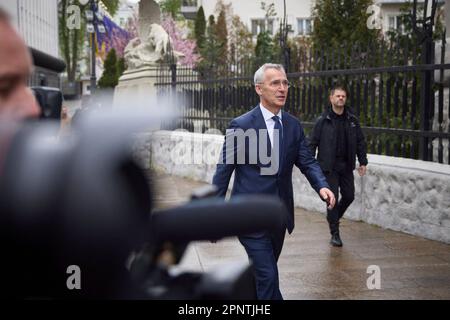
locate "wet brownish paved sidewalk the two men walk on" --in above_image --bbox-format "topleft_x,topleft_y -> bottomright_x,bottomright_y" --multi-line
153,175 -> 450,300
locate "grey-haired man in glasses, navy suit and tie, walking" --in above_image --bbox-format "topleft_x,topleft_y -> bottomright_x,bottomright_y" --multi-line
213,63 -> 335,300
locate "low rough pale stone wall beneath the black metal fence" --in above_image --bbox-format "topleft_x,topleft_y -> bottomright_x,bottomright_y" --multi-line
135,131 -> 450,243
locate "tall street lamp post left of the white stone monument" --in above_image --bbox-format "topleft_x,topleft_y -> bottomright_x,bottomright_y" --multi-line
86,0 -> 106,95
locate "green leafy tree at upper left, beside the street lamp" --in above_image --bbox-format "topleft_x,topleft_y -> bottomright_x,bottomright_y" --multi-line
58,0 -> 119,81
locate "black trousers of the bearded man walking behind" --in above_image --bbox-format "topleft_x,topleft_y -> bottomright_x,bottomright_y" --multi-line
325,162 -> 355,234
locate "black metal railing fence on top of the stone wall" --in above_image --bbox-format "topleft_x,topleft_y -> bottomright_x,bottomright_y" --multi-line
157,35 -> 450,164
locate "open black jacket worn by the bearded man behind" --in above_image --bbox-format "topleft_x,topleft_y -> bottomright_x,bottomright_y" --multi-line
308,106 -> 367,172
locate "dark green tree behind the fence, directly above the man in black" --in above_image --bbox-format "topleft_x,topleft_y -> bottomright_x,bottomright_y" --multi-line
311,0 -> 381,68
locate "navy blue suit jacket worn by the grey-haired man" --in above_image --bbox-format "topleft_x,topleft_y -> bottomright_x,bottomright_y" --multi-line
213,105 -> 329,233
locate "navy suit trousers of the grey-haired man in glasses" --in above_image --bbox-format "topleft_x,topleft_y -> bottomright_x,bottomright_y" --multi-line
239,228 -> 286,300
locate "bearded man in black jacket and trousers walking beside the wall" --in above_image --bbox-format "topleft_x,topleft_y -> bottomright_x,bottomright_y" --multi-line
309,86 -> 367,247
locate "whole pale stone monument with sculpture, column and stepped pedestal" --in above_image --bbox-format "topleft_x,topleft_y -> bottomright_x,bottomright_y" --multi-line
114,0 -> 170,107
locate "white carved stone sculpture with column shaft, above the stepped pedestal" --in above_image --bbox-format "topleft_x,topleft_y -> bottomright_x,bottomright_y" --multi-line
124,0 -> 170,70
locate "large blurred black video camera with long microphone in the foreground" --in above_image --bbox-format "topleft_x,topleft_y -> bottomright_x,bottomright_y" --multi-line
0,91 -> 284,299
